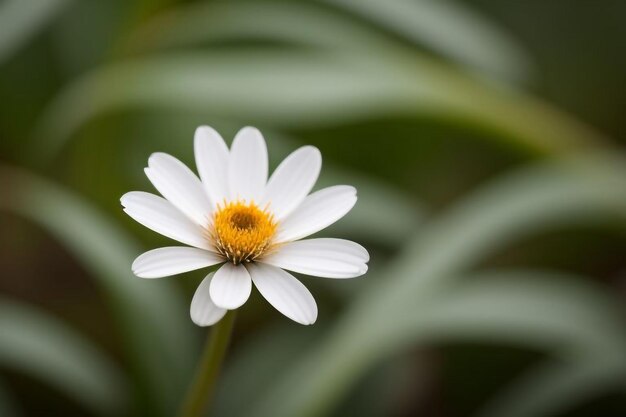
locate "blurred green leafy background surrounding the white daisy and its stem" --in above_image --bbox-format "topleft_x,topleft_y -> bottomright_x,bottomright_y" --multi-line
0,0 -> 626,417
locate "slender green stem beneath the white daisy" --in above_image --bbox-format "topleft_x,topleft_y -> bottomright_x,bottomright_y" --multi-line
178,310 -> 235,417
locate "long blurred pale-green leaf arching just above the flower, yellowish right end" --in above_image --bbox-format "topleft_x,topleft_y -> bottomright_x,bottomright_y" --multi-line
34,51 -> 602,164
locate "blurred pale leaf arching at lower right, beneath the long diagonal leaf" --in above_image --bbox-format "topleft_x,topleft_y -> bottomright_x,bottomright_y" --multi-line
382,271 -> 626,360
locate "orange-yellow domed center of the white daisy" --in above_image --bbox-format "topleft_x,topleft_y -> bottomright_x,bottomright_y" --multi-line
210,201 -> 277,265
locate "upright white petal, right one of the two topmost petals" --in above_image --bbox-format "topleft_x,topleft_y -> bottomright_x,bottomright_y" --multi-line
228,127 -> 267,202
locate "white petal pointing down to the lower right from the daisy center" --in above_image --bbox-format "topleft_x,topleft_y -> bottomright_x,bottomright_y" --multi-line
247,263 -> 317,324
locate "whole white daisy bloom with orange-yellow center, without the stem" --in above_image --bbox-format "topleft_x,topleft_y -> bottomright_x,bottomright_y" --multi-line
121,126 -> 369,326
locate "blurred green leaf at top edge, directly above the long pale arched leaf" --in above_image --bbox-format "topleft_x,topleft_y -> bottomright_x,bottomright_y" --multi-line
126,1 -> 370,53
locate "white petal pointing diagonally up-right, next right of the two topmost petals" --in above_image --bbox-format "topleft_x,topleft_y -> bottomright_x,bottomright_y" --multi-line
261,146 -> 322,220
